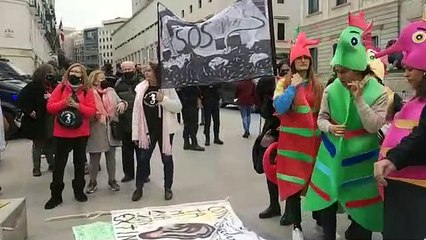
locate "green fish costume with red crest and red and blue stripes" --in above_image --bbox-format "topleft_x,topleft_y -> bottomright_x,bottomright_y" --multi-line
305,13 -> 384,232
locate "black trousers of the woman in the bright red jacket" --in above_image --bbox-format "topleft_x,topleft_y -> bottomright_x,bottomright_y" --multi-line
50,137 -> 88,199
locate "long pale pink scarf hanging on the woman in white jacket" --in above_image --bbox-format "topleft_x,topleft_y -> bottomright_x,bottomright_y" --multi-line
134,81 -> 172,156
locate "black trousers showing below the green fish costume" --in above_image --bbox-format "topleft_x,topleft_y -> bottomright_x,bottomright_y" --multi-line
320,202 -> 373,240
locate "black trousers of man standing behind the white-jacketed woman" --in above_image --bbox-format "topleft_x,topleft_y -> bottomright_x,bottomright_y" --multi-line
121,133 -> 146,178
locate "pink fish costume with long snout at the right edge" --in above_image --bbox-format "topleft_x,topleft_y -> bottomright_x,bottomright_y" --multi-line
376,19 -> 426,192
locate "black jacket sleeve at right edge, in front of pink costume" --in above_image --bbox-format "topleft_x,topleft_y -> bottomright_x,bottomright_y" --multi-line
386,104 -> 426,170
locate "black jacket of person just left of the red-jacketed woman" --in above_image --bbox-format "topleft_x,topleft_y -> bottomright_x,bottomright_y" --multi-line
18,81 -> 52,140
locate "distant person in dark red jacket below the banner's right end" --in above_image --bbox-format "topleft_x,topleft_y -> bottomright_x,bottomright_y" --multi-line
235,79 -> 256,138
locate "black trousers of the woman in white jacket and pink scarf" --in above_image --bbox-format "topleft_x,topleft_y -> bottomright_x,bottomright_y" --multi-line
136,133 -> 174,189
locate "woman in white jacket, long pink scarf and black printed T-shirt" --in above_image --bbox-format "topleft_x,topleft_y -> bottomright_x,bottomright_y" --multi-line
132,63 -> 182,201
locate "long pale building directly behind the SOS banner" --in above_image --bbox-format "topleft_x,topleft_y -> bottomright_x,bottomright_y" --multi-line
113,0 -> 300,64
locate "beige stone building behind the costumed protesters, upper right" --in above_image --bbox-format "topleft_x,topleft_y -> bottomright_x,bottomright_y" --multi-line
300,0 -> 426,80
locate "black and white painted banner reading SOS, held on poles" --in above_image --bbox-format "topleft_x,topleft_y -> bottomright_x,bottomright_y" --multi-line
158,0 -> 273,88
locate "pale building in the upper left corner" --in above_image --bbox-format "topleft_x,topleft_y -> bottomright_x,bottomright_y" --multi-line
0,0 -> 59,74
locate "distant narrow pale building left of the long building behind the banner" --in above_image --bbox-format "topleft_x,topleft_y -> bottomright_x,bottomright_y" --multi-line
99,18 -> 128,66
